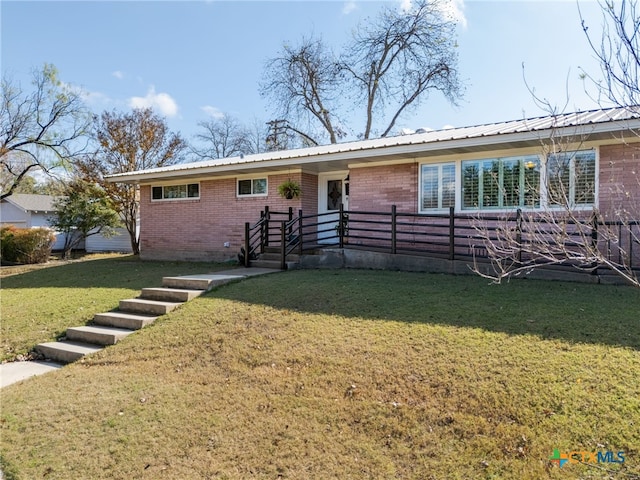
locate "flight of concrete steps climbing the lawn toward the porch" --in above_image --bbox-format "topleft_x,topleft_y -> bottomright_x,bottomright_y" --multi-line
35,274 -> 228,363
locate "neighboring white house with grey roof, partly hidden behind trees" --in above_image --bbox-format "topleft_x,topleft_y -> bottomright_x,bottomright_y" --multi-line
0,193 -> 132,253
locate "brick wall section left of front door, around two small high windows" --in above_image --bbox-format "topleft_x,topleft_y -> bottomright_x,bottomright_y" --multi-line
140,173 -> 318,261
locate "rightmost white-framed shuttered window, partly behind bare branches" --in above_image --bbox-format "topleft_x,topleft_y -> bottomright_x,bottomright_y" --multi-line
546,150 -> 596,207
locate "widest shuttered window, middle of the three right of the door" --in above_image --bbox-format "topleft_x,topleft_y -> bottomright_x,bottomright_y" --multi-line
462,155 -> 540,210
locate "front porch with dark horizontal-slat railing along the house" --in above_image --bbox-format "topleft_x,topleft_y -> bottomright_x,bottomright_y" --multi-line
239,206 -> 640,283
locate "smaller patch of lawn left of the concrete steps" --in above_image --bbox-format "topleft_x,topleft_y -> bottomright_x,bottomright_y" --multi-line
0,254 -> 229,362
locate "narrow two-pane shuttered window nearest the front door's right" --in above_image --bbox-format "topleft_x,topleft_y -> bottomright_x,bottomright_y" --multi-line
420,163 -> 456,211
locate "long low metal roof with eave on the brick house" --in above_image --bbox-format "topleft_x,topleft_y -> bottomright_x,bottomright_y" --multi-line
107,107 -> 640,183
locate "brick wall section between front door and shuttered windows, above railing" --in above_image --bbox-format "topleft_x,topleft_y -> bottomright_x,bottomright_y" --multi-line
349,163 -> 418,213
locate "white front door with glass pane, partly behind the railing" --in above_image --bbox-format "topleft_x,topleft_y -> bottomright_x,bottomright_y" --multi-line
318,172 -> 349,243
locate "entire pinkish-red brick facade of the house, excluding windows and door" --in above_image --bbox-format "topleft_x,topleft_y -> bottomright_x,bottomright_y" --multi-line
141,143 -> 640,260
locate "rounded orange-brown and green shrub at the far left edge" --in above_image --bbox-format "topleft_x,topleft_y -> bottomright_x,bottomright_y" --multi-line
0,226 -> 56,263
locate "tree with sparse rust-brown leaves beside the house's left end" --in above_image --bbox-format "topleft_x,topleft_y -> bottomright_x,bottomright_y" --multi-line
77,108 -> 187,255
